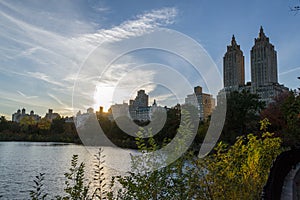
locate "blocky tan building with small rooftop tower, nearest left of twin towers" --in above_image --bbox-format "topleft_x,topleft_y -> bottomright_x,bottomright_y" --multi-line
185,86 -> 215,120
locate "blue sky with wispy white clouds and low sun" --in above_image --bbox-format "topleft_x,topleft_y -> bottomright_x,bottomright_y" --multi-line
0,0 -> 300,119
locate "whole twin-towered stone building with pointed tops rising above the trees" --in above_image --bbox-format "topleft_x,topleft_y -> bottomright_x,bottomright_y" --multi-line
218,27 -> 289,104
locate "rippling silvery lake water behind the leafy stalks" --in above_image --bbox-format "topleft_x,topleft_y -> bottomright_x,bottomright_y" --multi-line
0,142 -> 134,199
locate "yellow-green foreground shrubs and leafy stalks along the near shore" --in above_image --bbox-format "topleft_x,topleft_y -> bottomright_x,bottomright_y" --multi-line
27,109 -> 281,200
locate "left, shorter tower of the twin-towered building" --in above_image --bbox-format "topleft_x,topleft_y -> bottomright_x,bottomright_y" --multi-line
223,35 -> 245,88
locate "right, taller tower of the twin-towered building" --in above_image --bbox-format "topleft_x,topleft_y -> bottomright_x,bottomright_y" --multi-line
251,26 -> 278,87
